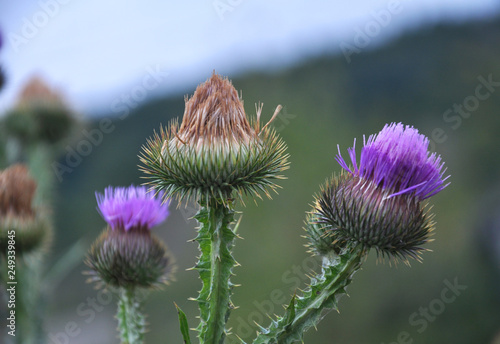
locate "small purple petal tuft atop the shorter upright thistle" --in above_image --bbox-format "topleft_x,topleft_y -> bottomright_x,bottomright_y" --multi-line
96,185 -> 168,231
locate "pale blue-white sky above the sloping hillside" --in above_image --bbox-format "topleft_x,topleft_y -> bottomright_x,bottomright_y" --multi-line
0,0 -> 500,114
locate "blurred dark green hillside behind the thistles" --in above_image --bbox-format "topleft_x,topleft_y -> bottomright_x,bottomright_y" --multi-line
50,19 -> 500,344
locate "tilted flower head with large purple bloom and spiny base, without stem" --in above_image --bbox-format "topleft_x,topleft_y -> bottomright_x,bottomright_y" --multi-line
306,123 -> 448,261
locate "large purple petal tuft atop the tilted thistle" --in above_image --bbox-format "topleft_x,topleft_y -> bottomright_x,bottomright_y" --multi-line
335,123 -> 449,201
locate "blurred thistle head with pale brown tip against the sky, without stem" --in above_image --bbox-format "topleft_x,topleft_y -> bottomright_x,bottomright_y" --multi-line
5,77 -> 74,144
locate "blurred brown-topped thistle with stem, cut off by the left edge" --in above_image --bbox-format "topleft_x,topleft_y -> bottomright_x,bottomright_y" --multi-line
0,164 -> 52,344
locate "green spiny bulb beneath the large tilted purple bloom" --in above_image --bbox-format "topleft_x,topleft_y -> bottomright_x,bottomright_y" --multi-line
306,173 -> 434,262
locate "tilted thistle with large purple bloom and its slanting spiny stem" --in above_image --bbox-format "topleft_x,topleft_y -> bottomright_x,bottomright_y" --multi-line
254,123 -> 448,344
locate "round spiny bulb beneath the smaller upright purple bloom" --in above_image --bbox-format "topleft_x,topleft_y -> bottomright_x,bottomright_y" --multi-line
85,228 -> 170,289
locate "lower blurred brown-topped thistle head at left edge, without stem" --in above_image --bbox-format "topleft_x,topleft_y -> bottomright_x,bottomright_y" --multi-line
0,164 -> 51,253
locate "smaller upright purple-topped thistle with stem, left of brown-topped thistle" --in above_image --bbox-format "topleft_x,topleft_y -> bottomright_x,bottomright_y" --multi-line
85,186 -> 171,344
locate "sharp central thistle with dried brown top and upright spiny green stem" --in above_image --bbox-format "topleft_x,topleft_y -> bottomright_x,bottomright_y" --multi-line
141,73 -> 288,344
